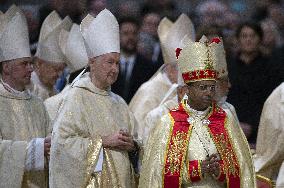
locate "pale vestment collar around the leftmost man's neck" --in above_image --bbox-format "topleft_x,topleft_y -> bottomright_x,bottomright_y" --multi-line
0,79 -> 32,100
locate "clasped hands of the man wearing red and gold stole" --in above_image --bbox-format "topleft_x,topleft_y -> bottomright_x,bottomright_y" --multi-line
201,154 -> 220,177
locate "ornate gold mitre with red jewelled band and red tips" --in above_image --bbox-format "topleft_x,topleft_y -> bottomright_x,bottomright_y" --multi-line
176,36 -> 224,83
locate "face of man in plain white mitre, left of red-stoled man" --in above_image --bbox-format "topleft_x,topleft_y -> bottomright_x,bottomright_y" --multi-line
89,52 -> 120,90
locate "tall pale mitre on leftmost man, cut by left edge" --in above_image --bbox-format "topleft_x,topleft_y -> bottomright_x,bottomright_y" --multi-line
0,6 -> 31,62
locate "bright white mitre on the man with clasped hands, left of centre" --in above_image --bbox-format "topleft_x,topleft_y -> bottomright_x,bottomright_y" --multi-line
80,9 -> 120,58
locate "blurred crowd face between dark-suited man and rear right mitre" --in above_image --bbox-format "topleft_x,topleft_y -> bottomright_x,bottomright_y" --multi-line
141,13 -> 161,38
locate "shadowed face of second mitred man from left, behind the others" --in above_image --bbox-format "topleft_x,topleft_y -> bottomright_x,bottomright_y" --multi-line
35,58 -> 66,88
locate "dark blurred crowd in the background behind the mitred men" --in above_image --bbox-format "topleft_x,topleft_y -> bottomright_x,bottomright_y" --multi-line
0,0 -> 284,147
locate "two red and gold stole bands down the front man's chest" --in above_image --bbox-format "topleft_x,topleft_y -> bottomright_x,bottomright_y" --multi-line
163,104 -> 240,188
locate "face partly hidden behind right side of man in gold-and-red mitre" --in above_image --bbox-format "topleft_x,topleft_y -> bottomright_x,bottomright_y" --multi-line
215,76 -> 231,102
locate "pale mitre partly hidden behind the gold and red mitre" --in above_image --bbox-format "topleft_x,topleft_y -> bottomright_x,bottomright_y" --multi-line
158,14 -> 195,63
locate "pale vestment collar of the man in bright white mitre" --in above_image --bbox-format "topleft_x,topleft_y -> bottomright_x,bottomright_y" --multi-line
72,72 -> 111,96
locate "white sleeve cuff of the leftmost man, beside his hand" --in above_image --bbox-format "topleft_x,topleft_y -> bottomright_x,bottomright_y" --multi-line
25,138 -> 44,171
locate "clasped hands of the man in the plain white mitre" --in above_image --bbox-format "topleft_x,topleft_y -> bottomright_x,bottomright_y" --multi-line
102,130 -> 135,151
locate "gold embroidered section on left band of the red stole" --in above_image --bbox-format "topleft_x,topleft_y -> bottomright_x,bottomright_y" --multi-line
165,131 -> 188,175
